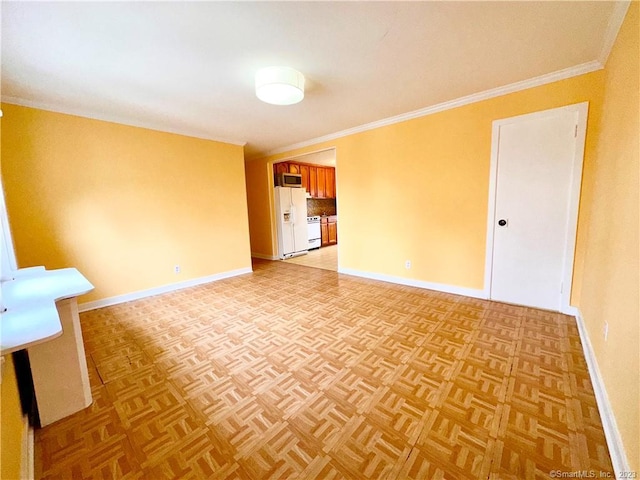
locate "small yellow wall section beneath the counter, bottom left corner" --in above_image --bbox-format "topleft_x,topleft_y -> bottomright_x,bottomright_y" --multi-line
0,355 -> 23,479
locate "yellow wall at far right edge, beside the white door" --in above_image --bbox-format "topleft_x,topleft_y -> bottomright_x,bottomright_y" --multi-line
579,2 -> 640,472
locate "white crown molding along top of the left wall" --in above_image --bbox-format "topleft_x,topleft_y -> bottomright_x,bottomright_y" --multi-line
2,95 -> 247,147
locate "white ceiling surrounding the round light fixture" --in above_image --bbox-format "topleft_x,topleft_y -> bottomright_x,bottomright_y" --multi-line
2,1 -> 620,157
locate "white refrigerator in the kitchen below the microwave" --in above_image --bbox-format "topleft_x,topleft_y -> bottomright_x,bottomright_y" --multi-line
275,187 -> 309,258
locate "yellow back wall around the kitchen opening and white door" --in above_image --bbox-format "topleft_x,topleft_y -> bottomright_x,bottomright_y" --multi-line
247,71 -> 604,291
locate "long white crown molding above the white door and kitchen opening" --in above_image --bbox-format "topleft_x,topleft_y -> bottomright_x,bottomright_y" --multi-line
254,60 -> 603,160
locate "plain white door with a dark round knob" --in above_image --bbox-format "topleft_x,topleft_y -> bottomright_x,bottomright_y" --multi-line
487,104 -> 587,311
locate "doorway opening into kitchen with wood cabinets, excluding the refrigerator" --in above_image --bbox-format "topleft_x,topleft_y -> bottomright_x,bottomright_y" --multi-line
273,148 -> 338,271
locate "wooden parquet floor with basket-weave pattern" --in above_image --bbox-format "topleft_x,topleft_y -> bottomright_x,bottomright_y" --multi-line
36,260 -> 612,480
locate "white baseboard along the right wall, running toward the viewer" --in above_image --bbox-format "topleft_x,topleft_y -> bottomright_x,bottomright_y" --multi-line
573,307 -> 631,478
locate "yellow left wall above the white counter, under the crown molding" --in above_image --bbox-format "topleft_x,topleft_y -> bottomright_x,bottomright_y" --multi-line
2,104 -> 251,302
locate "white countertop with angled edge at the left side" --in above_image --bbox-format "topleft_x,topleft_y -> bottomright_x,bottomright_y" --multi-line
0,267 -> 94,355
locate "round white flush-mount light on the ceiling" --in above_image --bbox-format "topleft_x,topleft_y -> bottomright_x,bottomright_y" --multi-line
256,67 -> 304,105
